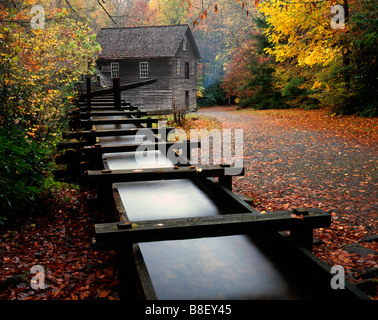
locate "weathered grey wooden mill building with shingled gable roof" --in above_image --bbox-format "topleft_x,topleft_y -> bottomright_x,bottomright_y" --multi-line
97,25 -> 200,113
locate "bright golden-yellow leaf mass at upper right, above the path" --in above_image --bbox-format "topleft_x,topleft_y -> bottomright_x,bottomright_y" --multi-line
260,0 -> 341,66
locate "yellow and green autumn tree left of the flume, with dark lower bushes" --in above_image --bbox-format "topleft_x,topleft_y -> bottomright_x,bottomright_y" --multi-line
0,1 -> 100,222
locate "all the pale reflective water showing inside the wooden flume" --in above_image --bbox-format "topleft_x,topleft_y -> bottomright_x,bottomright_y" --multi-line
100,122 -> 304,299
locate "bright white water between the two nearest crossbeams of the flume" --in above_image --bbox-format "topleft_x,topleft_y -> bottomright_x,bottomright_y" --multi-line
116,179 -> 220,221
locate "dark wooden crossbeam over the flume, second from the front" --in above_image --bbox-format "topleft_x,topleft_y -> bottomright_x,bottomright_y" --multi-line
87,166 -> 244,184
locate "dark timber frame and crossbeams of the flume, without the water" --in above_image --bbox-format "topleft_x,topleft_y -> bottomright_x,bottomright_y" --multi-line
57,78 -> 366,299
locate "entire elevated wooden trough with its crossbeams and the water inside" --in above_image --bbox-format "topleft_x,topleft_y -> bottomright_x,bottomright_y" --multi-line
59,80 -> 367,299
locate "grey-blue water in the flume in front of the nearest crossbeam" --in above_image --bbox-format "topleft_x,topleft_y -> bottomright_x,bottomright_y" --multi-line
139,236 -> 295,300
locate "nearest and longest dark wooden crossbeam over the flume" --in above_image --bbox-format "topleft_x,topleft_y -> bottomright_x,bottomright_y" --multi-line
95,209 -> 331,246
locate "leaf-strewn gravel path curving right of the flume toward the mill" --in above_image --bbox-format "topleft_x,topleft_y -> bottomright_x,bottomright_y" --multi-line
199,108 -> 378,234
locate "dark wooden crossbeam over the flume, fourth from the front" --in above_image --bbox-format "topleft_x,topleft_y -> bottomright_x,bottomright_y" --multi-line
62,127 -> 175,139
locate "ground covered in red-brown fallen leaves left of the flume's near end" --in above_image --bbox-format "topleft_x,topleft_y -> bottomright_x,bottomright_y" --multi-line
0,188 -> 119,300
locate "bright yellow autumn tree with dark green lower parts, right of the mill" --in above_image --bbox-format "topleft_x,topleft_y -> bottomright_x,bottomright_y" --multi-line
260,0 -> 377,115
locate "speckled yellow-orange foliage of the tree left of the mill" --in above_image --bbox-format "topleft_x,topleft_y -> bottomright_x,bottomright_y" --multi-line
0,1 -> 100,138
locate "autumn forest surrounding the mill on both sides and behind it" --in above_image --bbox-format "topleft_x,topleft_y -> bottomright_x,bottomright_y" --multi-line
0,0 -> 378,225
